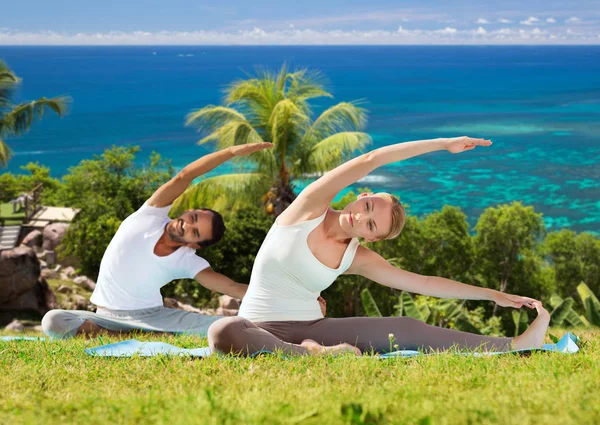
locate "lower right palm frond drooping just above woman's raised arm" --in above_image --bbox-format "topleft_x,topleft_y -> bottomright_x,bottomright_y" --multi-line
299,131 -> 371,173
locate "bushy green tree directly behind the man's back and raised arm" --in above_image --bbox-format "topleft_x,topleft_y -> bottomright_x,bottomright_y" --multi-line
57,146 -> 173,277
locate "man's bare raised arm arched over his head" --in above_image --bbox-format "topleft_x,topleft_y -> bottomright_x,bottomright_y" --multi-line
148,143 -> 273,208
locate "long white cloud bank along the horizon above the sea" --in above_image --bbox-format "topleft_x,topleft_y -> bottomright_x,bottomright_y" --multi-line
0,26 -> 600,46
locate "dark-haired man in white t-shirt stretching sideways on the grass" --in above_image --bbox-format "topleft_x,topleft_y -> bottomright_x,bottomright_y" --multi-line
42,143 -> 272,338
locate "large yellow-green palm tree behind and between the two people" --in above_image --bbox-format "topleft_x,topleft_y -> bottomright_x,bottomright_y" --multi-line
175,65 -> 371,215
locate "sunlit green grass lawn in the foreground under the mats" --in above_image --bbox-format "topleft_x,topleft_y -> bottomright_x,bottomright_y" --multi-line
0,330 -> 600,425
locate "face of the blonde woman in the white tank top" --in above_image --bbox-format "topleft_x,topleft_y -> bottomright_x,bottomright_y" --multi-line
340,193 -> 392,242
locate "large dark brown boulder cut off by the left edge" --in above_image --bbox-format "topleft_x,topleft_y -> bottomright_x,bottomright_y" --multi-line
0,245 -> 40,304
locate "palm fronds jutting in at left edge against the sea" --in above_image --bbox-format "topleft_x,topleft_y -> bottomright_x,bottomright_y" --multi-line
0,60 -> 70,167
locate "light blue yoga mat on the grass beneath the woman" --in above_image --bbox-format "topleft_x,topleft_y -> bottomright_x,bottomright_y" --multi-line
85,333 -> 579,358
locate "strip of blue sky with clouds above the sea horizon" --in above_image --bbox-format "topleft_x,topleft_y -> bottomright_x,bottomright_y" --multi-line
0,0 -> 600,45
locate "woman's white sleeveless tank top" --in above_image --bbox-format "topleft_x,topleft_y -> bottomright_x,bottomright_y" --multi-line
239,211 -> 359,322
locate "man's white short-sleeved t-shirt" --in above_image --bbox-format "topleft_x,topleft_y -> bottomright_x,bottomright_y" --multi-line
90,202 -> 210,310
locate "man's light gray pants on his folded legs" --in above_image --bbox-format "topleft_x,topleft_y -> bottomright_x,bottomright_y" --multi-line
42,306 -> 223,338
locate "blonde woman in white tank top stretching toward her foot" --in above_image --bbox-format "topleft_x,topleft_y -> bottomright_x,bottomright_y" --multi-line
208,137 -> 550,355
